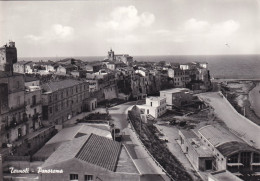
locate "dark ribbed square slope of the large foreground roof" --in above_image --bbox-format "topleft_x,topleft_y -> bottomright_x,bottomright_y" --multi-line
76,134 -> 122,171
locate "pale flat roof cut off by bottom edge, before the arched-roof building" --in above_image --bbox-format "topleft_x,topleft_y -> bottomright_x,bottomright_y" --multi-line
209,170 -> 243,181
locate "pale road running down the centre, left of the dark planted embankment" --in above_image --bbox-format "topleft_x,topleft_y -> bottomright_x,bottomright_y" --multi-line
108,102 -> 170,181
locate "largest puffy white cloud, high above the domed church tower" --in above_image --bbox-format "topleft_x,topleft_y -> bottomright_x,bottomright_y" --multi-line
97,6 -> 155,31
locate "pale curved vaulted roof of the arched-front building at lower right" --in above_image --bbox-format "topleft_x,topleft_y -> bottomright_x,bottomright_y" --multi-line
198,125 -> 244,147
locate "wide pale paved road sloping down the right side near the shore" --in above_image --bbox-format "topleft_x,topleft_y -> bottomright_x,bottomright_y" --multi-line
198,92 -> 260,149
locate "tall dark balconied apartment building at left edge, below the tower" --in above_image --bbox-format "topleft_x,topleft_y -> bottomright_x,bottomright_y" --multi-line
0,71 -> 29,145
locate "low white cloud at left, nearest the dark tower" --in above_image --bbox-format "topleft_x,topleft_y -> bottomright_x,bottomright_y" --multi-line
25,24 -> 74,42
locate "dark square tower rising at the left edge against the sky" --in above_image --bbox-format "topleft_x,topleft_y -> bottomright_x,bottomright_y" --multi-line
0,41 -> 17,71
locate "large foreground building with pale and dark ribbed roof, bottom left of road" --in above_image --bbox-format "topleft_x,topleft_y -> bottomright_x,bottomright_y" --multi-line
39,133 -> 141,181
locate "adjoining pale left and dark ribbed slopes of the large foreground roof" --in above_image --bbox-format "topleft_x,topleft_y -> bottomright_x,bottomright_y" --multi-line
42,134 -> 122,171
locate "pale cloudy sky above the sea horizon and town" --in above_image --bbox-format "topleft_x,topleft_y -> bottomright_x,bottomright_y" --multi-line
0,0 -> 260,57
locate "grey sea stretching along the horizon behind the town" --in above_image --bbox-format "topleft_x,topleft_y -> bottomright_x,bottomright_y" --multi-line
18,55 -> 260,79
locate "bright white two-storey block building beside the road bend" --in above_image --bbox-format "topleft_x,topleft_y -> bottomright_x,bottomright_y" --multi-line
138,97 -> 166,118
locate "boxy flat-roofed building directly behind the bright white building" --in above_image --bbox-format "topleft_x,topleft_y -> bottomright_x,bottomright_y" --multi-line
160,88 -> 193,109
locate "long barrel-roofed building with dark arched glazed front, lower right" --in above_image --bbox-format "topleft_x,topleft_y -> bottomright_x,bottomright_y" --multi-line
198,125 -> 260,175
